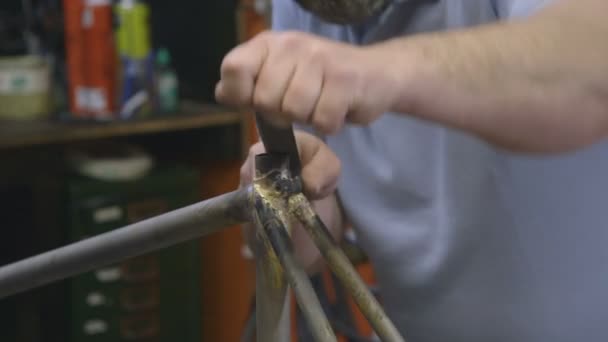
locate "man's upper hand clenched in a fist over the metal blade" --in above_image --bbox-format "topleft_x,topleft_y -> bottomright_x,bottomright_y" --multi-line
216,32 -> 397,134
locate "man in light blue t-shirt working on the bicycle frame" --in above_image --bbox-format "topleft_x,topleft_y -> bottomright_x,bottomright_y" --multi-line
217,0 -> 608,342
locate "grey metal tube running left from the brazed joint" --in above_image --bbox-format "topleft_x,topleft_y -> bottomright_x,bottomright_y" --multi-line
0,188 -> 251,298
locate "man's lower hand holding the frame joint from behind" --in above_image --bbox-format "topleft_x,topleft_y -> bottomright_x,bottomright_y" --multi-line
241,131 -> 343,273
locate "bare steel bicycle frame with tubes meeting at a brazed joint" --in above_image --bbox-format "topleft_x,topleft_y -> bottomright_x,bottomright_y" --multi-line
0,154 -> 404,342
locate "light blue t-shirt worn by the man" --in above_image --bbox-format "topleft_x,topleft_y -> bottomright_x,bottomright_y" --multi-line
273,0 -> 608,342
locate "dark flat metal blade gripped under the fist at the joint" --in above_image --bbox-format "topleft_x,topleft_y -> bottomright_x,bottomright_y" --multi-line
255,113 -> 302,177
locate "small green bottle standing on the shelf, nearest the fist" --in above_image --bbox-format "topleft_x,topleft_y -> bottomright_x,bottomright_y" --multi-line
156,48 -> 179,113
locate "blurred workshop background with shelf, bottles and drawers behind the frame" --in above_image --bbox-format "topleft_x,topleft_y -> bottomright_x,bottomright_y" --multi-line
0,0 -> 380,342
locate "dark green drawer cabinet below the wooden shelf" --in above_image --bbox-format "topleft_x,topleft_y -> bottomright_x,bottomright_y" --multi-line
68,167 -> 202,342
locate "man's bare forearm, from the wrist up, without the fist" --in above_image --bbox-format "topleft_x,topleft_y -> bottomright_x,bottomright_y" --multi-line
382,0 -> 608,152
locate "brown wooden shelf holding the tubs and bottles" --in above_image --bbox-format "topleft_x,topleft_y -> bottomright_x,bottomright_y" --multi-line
0,105 -> 243,150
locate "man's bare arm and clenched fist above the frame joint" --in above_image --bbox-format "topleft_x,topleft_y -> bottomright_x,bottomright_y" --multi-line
216,0 -> 608,152
